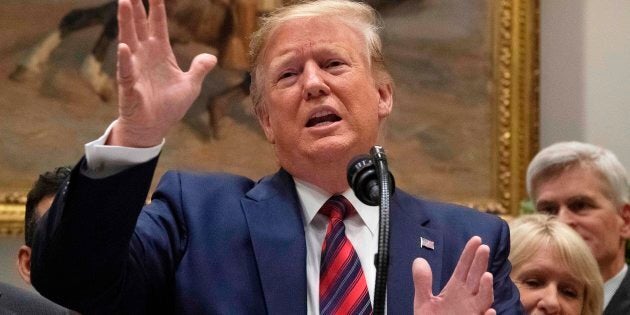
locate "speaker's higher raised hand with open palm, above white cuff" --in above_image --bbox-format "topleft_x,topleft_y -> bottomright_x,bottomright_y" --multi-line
107,0 -> 217,147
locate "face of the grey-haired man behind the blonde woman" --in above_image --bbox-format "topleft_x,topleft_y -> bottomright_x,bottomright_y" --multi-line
534,166 -> 630,280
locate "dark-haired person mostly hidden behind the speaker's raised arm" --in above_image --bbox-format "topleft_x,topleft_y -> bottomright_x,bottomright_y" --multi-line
0,167 -> 74,315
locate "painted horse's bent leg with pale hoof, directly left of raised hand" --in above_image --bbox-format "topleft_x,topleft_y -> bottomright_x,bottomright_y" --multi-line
81,8 -> 118,102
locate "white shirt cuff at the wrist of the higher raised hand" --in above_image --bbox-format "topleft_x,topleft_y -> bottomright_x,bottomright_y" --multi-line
84,120 -> 165,178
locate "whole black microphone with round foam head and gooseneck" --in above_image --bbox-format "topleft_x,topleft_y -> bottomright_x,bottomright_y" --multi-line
347,146 -> 395,315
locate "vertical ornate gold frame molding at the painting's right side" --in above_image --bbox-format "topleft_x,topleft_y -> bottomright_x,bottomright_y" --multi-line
491,0 -> 540,216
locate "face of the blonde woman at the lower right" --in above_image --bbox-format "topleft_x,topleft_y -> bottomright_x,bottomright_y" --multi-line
511,247 -> 585,315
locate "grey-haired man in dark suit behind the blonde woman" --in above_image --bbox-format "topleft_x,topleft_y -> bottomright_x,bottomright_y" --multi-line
527,141 -> 630,315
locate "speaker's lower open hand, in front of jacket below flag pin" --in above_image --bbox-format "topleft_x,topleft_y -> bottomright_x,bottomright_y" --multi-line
412,236 -> 496,315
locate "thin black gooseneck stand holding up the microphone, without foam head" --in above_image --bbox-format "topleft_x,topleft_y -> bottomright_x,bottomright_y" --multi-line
370,146 -> 393,315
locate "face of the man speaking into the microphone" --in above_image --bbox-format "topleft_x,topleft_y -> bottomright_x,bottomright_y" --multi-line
260,18 -> 392,185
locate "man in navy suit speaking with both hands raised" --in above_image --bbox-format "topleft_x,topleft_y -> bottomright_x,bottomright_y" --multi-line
32,0 -> 522,314
